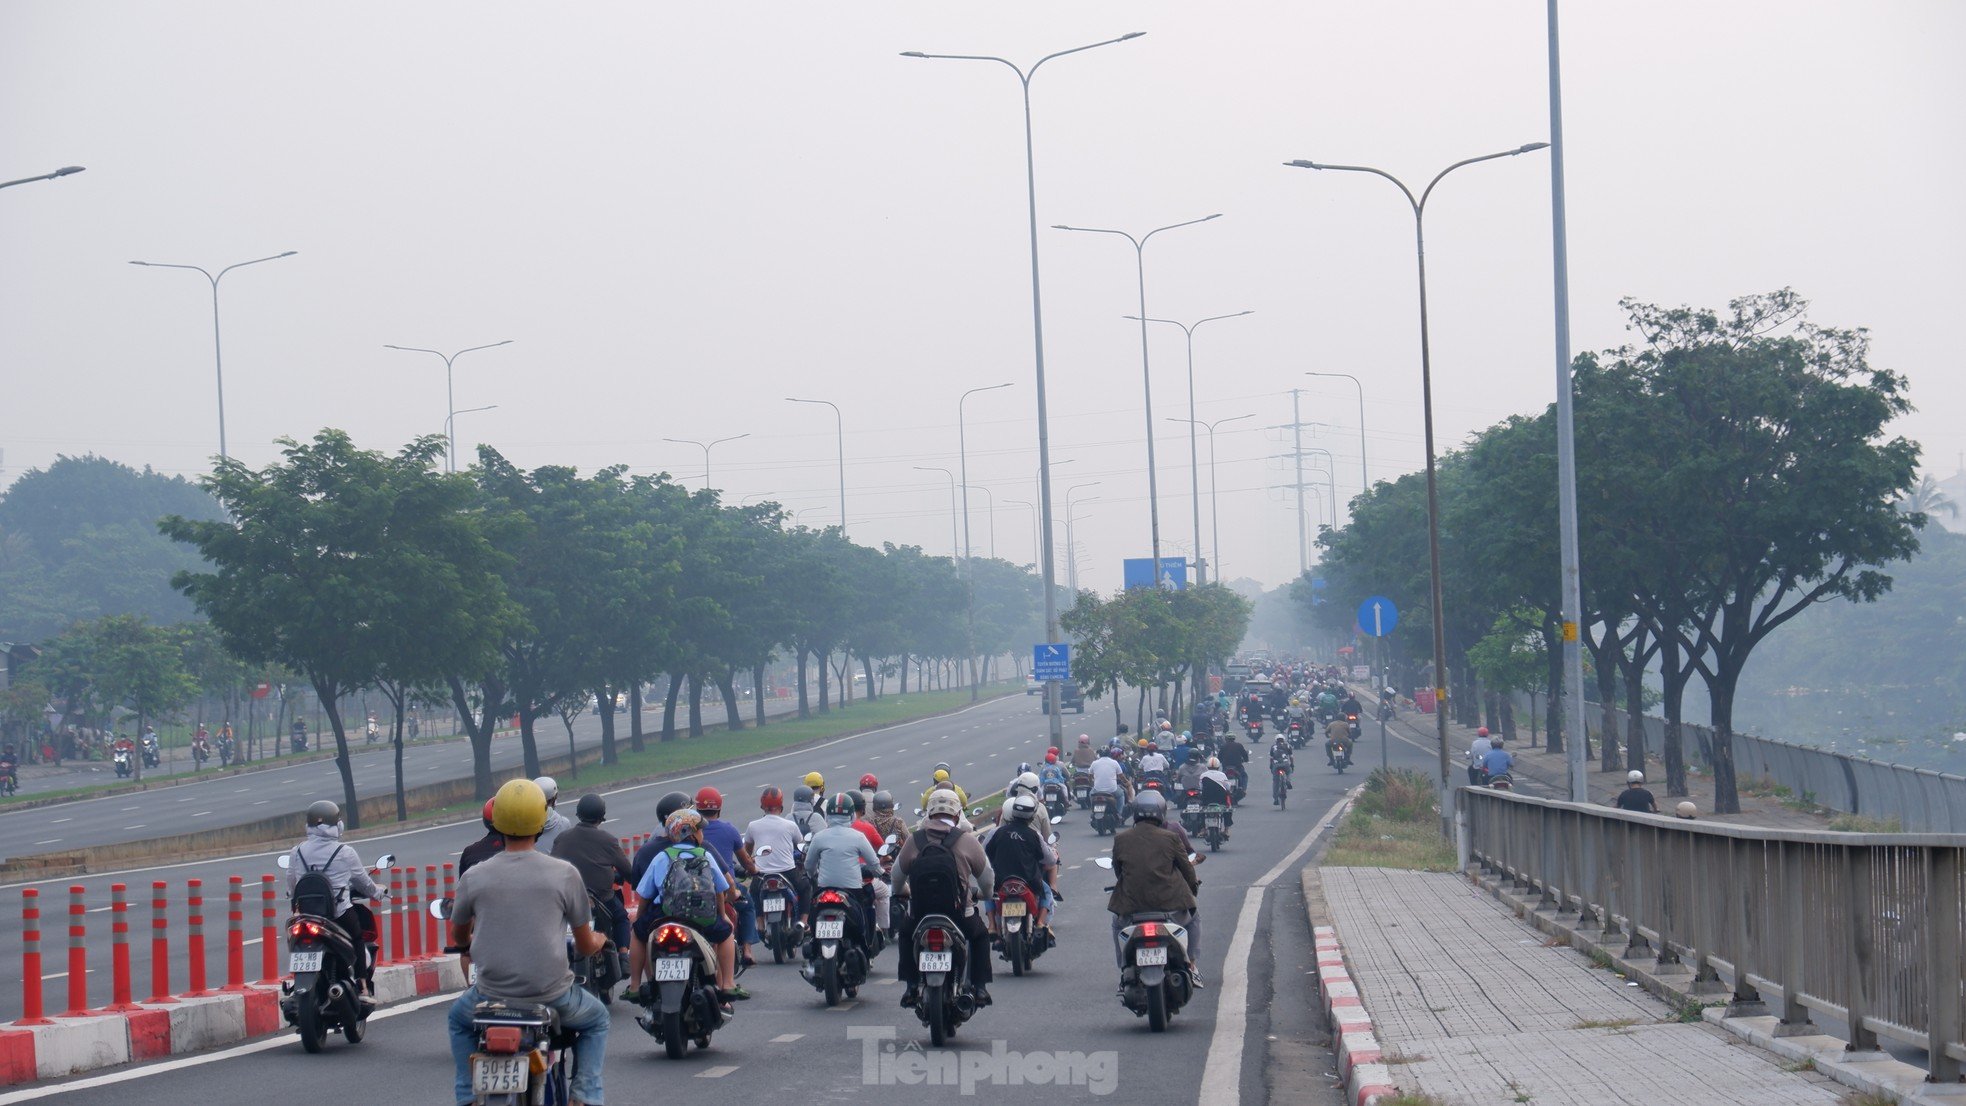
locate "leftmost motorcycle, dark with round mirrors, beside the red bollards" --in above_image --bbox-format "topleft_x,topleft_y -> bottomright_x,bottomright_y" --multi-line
277,853 -> 393,1053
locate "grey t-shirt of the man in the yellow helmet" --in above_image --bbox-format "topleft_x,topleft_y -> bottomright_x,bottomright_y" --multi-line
450,849 -> 590,1002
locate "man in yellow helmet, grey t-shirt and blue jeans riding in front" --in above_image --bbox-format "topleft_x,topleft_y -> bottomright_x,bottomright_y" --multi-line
444,780 -> 607,1104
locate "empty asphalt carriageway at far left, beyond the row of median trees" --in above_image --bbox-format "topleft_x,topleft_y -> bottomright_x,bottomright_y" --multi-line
0,699 -> 798,858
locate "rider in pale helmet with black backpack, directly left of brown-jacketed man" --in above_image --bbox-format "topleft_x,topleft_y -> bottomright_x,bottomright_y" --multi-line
895,792 -> 997,1006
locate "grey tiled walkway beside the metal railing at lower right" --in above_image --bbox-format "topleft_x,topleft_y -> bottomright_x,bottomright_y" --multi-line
1323,868 -> 1842,1106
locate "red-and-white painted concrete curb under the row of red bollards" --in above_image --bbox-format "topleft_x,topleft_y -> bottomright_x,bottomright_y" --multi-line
0,957 -> 464,1086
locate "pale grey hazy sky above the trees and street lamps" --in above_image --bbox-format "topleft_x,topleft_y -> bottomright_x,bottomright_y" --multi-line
0,0 -> 1966,589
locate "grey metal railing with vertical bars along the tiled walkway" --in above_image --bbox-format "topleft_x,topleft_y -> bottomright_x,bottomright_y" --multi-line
1459,788 -> 1966,1082
